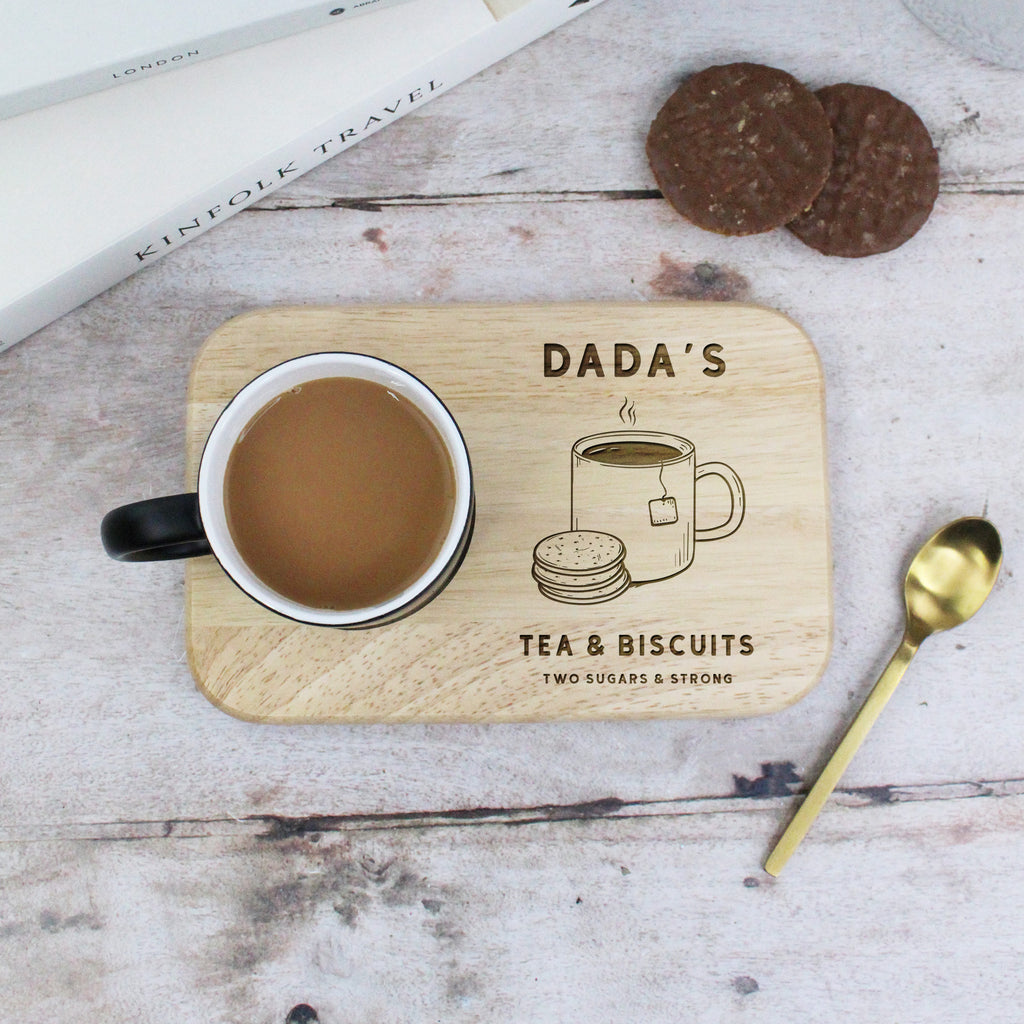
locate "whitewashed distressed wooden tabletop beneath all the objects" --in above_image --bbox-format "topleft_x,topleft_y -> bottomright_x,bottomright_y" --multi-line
0,0 -> 1024,1024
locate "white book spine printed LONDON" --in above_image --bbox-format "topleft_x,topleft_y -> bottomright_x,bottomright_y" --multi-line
0,0 -> 409,120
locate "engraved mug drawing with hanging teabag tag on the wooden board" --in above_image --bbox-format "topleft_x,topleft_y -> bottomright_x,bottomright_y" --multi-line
571,430 -> 744,584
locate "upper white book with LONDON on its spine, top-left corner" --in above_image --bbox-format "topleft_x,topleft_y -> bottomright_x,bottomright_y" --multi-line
0,0 -> 415,118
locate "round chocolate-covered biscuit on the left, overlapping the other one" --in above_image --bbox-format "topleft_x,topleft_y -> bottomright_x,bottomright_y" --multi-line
647,63 -> 833,234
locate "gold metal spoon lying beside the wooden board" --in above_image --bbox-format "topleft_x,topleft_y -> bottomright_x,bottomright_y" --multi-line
765,517 -> 1002,874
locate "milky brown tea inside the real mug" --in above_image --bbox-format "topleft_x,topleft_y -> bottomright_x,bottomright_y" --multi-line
224,377 -> 456,611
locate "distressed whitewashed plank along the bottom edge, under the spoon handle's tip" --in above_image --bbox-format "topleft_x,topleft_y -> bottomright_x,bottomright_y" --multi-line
0,795 -> 1024,1024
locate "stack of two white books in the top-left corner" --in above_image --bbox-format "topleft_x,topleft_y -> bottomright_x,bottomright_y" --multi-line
0,0 -> 601,350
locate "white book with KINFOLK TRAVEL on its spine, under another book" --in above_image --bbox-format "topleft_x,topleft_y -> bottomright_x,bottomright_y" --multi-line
0,0 -> 600,351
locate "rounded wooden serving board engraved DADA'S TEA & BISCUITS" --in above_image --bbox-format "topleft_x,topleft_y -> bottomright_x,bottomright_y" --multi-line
185,302 -> 831,723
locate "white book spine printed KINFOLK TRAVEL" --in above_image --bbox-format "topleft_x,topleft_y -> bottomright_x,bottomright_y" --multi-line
0,0 -> 602,351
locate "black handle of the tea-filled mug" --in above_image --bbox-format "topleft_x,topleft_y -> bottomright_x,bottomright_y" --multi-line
99,494 -> 212,562
